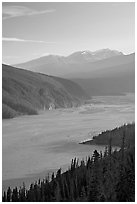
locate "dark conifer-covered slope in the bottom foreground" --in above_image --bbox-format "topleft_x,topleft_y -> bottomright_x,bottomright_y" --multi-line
3,124 -> 135,202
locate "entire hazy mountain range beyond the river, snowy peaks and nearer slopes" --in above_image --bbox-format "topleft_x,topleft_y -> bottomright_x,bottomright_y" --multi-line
15,49 -> 135,96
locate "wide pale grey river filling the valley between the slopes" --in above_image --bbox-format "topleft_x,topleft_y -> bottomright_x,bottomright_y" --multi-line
2,94 -> 135,189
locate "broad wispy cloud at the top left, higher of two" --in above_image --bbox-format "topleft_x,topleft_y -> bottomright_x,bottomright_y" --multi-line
2,6 -> 55,20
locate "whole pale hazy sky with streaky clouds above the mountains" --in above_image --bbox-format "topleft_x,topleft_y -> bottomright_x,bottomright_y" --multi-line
2,2 -> 135,64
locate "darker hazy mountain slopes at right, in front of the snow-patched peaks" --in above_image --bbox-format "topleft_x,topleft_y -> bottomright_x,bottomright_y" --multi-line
69,54 -> 135,95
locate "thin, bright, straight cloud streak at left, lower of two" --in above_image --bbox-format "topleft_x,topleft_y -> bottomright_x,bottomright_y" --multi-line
2,37 -> 56,44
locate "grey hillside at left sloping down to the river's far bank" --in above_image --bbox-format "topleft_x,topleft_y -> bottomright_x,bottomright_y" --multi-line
2,64 -> 89,118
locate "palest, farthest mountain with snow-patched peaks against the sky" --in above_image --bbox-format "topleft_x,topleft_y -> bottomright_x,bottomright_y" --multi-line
15,49 -> 123,76
